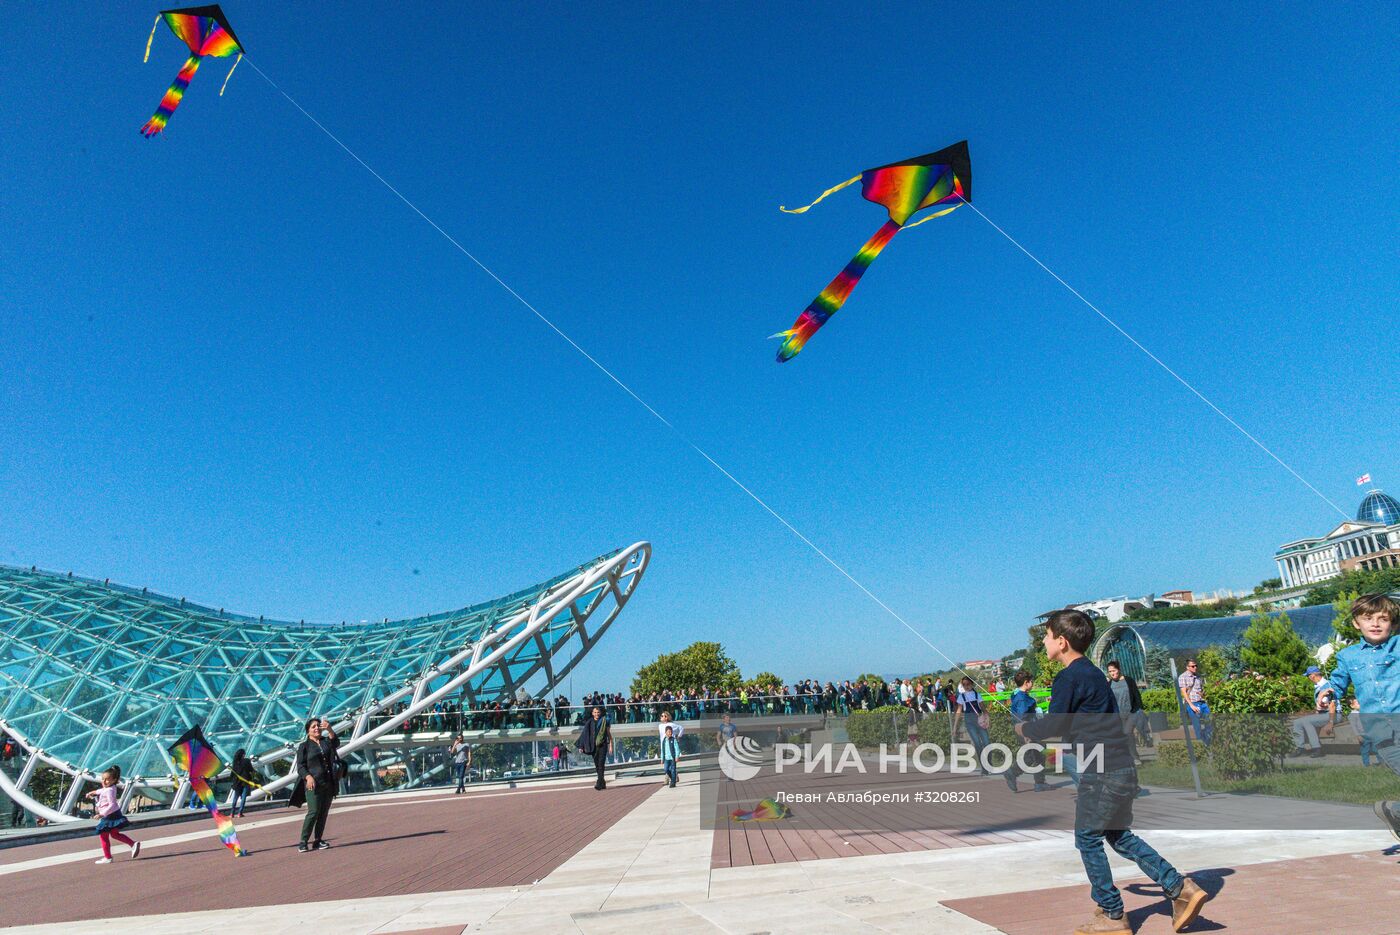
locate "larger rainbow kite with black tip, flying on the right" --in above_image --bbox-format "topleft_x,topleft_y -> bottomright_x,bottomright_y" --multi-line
773,140 -> 972,364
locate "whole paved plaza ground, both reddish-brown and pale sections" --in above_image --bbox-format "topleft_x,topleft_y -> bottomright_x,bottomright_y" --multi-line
0,771 -> 1400,935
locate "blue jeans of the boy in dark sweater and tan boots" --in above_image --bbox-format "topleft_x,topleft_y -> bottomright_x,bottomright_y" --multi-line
1074,767 -> 1182,915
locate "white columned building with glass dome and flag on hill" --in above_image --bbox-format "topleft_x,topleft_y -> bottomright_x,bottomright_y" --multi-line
1274,490 -> 1400,588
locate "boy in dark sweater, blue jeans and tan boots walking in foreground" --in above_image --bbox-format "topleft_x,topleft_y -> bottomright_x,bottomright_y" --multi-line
1016,610 -> 1208,935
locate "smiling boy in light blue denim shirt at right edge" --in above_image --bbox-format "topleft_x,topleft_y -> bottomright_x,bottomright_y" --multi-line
1329,593 -> 1400,841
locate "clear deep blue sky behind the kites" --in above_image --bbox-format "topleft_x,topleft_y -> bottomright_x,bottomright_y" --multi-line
0,1 -> 1400,691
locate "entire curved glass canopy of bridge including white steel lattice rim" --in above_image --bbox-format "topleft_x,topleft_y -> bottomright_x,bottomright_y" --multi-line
0,542 -> 651,822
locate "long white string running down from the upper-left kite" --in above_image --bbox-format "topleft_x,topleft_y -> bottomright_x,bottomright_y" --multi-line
240,59 -> 1005,707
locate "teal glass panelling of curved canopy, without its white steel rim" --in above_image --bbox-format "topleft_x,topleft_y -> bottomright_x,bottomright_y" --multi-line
0,551 -> 617,778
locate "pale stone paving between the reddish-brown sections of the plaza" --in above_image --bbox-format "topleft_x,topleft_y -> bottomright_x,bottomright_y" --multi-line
0,774 -> 1400,935
